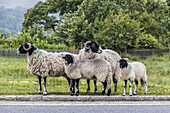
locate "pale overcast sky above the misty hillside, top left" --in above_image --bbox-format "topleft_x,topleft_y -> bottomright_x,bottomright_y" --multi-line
0,0 -> 45,8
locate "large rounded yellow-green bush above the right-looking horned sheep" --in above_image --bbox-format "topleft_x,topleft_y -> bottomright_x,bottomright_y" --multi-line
93,11 -> 142,51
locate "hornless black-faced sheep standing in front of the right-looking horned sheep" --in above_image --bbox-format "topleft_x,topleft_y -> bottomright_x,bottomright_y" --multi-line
63,54 -> 112,96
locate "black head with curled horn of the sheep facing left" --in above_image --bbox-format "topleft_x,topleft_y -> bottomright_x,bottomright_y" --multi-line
17,43 -> 37,55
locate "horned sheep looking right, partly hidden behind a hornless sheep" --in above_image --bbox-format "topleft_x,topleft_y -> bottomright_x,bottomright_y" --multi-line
78,41 -> 121,92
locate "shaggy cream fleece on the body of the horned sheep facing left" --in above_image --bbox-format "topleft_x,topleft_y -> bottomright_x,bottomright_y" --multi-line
27,49 -> 75,77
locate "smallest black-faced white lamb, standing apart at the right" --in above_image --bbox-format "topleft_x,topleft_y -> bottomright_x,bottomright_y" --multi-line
118,59 -> 147,96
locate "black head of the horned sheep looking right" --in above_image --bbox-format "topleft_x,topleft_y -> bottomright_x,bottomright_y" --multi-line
84,41 -> 102,54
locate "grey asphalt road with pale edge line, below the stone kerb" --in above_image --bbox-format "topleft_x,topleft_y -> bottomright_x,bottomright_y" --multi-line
0,101 -> 170,113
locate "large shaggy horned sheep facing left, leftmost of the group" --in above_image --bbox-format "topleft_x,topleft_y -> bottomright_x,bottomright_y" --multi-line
17,43 -> 76,95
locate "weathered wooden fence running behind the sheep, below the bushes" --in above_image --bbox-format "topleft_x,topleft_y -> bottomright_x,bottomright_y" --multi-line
0,49 -> 170,58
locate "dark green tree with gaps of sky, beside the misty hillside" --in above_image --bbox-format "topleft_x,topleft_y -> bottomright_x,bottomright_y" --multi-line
22,0 -> 82,32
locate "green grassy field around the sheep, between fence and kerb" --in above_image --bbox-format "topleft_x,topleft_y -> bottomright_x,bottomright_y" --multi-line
0,54 -> 170,95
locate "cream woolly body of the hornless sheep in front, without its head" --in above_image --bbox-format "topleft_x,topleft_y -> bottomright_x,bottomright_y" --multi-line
65,59 -> 112,89
